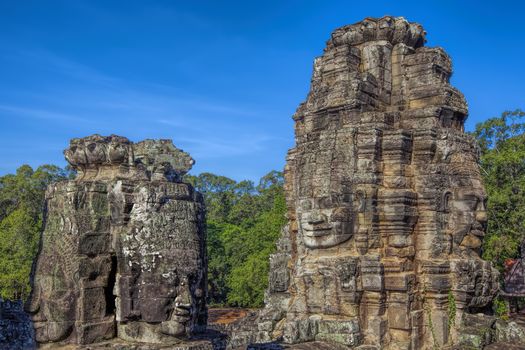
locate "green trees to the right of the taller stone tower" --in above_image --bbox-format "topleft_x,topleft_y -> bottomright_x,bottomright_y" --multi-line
473,110 -> 525,269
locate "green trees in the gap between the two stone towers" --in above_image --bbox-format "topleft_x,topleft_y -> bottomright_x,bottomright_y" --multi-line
185,171 -> 286,307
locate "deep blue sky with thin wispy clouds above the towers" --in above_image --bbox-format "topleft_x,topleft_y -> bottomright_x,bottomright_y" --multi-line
0,0 -> 525,180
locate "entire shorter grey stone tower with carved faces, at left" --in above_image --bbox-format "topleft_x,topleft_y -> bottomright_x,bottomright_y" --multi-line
27,135 -> 207,344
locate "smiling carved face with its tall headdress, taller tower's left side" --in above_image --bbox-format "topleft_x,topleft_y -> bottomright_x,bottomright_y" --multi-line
292,121 -> 358,249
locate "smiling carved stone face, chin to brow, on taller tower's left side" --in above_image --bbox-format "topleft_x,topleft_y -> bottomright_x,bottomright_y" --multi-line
297,194 -> 358,248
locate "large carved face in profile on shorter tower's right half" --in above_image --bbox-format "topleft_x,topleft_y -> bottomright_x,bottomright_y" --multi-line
118,184 -> 206,341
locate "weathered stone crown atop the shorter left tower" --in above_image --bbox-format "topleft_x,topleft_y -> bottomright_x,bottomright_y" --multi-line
64,134 -> 195,182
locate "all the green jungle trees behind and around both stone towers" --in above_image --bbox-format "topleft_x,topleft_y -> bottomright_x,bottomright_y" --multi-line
0,110 -> 525,307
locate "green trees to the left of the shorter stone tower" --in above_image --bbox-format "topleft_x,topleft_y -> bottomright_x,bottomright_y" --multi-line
0,165 -> 70,300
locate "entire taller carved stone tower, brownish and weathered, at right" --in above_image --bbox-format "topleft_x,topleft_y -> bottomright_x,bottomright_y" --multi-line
257,17 -> 498,350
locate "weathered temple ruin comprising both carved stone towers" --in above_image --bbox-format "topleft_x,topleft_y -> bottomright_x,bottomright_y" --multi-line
19,16 -> 512,350
